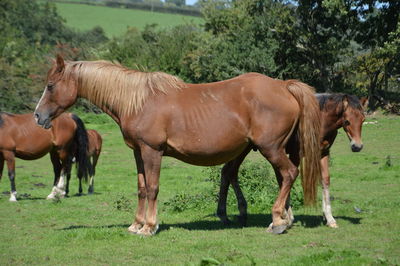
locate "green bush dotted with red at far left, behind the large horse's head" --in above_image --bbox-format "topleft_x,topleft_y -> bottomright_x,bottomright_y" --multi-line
0,0 -> 107,113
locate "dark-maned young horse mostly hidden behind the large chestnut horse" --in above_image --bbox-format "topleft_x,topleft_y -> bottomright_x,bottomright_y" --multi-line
217,93 -> 367,228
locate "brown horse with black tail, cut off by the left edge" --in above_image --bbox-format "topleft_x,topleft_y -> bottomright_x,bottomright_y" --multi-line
0,112 -> 89,201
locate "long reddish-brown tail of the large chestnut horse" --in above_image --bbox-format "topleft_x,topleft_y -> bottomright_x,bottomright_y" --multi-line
287,80 -> 321,204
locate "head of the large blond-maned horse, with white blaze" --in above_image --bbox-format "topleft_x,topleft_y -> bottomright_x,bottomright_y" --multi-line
34,55 -> 77,129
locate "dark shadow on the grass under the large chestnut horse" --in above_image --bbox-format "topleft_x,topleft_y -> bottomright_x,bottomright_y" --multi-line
59,214 -> 362,232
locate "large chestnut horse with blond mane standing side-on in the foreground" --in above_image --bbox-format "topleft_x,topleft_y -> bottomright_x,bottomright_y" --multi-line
35,56 -> 320,235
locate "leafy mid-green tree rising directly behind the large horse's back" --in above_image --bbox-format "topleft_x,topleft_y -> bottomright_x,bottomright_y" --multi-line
184,0 -> 278,82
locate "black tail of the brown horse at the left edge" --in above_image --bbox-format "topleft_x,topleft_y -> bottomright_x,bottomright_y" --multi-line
72,114 -> 92,181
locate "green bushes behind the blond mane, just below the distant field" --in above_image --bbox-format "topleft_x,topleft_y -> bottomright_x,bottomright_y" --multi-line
101,24 -> 198,75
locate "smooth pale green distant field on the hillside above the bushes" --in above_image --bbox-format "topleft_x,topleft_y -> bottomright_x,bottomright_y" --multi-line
56,3 -> 203,37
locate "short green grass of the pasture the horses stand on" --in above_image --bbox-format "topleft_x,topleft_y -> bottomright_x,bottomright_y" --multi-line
0,110 -> 400,265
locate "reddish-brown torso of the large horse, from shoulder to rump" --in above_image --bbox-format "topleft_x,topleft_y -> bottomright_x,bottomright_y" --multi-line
130,73 -> 299,165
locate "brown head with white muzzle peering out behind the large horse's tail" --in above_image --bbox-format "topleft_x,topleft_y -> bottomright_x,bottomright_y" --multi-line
342,95 -> 366,152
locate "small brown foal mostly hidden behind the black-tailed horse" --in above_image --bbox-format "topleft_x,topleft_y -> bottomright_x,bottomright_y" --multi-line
65,129 -> 103,195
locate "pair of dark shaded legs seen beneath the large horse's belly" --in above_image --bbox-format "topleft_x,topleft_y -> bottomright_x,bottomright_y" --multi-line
217,147 -> 251,226
